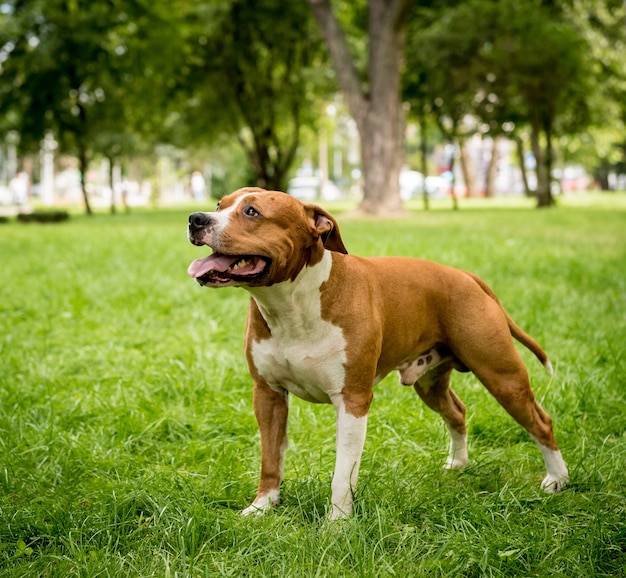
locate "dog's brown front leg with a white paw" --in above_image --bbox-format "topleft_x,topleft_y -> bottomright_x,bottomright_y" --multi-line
242,379 -> 289,516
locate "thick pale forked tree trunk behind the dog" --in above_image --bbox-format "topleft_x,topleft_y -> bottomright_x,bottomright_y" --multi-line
309,0 -> 413,214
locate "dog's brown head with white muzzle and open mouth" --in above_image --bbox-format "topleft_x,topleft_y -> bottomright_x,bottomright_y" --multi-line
188,188 -> 347,287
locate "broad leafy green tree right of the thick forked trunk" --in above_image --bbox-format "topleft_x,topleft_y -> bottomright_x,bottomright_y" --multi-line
407,0 -> 594,206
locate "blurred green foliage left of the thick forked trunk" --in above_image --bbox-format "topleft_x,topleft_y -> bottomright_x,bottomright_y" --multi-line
0,0 -> 331,194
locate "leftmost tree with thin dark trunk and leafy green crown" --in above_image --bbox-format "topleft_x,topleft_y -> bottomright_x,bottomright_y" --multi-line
0,0 -> 183,214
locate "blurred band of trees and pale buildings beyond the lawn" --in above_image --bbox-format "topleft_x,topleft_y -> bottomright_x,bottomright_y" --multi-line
0,0 -> 626,214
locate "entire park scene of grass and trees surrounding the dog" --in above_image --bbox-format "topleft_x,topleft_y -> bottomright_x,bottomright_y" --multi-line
0,0 -> 626,577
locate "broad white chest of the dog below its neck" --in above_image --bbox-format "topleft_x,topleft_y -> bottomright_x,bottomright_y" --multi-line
252,323 -> 346,403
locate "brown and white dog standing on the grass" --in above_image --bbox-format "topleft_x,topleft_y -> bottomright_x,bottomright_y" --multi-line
188,188 -> 568,519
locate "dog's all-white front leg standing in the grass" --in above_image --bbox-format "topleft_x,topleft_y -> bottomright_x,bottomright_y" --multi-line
330,396 -> 369,520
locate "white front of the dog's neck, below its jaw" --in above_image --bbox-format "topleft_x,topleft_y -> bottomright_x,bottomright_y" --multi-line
247,250 -> 332,339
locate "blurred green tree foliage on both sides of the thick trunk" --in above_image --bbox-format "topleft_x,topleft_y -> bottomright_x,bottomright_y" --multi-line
0,0 -> 626,207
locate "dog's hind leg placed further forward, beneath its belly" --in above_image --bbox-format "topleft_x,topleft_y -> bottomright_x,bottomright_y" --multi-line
413,366 -> 468,470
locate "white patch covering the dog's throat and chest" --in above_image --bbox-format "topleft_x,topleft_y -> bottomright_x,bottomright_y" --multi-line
250,251 -> 346,403
